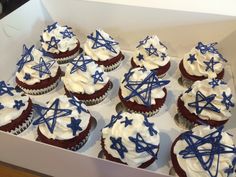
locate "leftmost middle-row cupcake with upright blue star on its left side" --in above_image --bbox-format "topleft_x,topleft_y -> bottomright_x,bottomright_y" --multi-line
16,45 -> 61,95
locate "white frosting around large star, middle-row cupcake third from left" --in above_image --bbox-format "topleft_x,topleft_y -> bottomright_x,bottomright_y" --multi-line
120,67 -> 169,105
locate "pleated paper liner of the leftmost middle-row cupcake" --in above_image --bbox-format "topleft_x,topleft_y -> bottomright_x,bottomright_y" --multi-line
17,78 -> 60,95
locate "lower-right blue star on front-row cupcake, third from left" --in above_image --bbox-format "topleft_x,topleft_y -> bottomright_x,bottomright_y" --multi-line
129,133 -> 159,158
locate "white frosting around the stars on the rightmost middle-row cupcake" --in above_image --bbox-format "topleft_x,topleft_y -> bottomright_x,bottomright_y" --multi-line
180,79 -> 233,121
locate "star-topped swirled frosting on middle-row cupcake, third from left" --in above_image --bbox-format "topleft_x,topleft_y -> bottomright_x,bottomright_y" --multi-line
120,67 -> 169,106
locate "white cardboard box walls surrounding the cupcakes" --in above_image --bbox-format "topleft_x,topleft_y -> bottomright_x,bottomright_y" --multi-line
0,0 -> 236,177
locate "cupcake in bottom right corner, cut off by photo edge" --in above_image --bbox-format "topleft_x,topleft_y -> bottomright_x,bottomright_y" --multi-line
171,125 -> 236,177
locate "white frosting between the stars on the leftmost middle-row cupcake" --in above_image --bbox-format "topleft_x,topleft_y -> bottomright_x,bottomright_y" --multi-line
16,47 -> 59,85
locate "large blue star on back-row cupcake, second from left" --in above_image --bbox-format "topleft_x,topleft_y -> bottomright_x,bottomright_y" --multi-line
87,30 -> 119,54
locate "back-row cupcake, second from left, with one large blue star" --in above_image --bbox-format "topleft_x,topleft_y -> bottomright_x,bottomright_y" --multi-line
84,29 -> 124,71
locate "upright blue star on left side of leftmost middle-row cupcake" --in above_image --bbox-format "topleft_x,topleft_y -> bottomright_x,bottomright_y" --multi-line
16,44 -> 34,72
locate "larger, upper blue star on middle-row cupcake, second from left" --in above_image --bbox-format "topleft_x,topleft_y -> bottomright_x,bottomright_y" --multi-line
70,54 -> 93,74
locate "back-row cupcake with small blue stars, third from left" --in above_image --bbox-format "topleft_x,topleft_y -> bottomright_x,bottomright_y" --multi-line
131,36 -> 170,77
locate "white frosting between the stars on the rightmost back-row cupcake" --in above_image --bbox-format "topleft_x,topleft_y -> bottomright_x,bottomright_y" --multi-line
183,44 -> 225,78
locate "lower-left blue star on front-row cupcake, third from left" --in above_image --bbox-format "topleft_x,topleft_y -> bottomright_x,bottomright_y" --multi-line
110,137 -> 128,159
